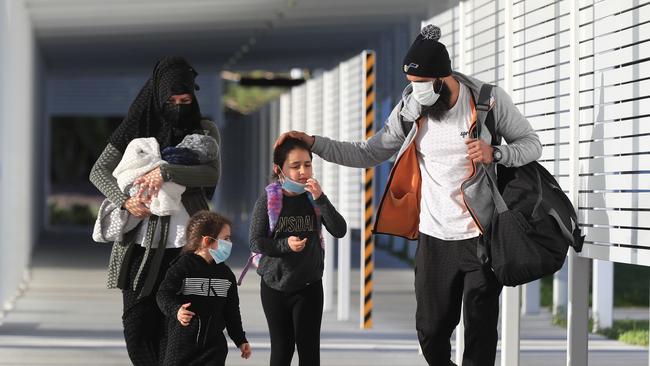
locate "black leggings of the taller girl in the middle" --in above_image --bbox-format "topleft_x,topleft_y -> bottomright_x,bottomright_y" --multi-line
260,280 -> 323,366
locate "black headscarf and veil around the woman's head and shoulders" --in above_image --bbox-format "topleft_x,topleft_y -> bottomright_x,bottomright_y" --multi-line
109,57 -> 201,153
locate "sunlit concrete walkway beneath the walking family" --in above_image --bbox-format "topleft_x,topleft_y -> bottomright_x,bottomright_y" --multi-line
0,230 -> 648,366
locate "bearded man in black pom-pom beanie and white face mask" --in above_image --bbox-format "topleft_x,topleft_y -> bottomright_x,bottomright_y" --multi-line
276,25 -> 542,366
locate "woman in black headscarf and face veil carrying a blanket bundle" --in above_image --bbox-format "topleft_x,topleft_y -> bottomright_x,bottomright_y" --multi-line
90,57 -> 221,366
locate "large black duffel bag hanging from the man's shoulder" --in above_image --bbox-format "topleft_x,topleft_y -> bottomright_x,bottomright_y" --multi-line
482,162 -> 584,286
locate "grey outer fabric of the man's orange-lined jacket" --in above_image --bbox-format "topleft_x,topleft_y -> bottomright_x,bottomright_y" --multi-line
312,72 -> 542,237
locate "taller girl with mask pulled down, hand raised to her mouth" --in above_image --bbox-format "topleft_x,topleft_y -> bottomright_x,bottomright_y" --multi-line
249,138 -> 347,366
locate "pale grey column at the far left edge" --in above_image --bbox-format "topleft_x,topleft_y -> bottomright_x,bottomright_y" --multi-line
0,0 -> 38,310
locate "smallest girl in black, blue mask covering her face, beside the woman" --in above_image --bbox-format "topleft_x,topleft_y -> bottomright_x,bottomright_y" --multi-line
156,211 -> 251,365
